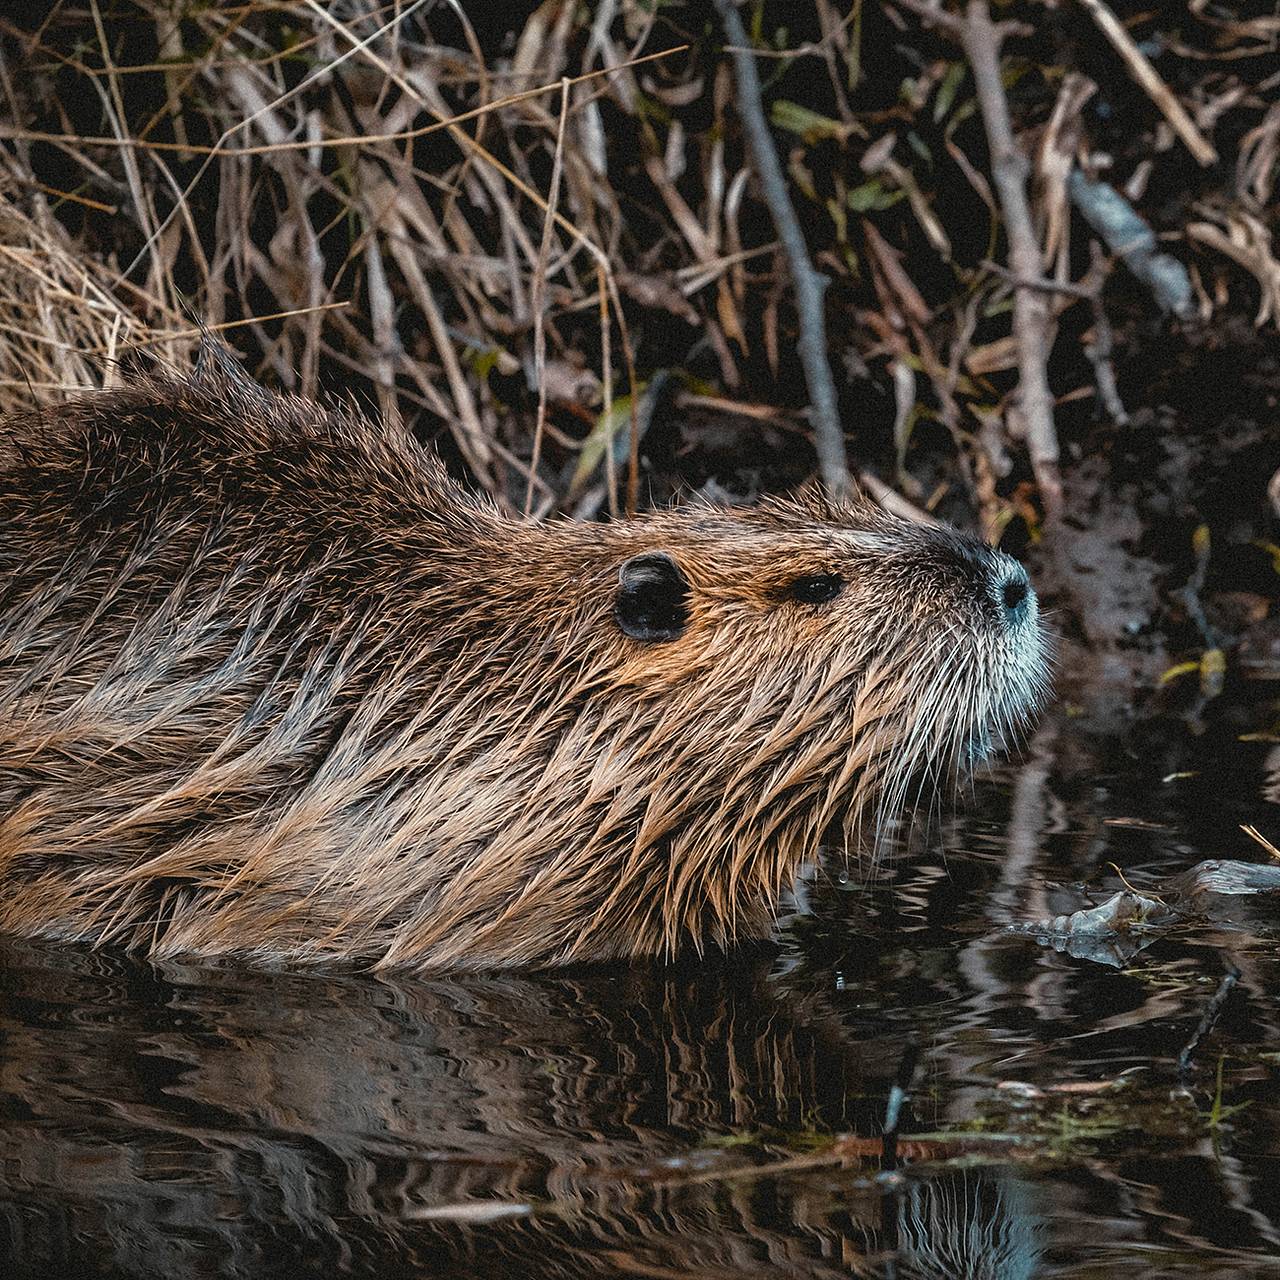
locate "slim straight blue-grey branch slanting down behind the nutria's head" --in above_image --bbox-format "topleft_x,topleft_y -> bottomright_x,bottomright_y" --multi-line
716,0 -> 851,494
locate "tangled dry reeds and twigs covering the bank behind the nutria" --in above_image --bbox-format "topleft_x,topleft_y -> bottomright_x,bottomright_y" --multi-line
0,0 -> 1280,538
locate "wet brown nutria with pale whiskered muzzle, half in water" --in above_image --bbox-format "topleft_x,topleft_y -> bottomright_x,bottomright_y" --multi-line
0,346 -> 1044,969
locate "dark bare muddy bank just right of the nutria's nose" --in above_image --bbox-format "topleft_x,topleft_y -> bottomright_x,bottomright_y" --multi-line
1027,324 -> 1280,730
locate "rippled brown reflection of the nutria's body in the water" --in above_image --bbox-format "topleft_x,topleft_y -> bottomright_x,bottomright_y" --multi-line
4,947 -> 1030,1276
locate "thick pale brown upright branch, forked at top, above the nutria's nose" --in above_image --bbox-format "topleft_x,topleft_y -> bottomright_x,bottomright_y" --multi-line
896,0 -> 1062,518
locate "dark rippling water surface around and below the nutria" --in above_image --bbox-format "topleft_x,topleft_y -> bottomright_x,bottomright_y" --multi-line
0,713 -> 1280,1280
